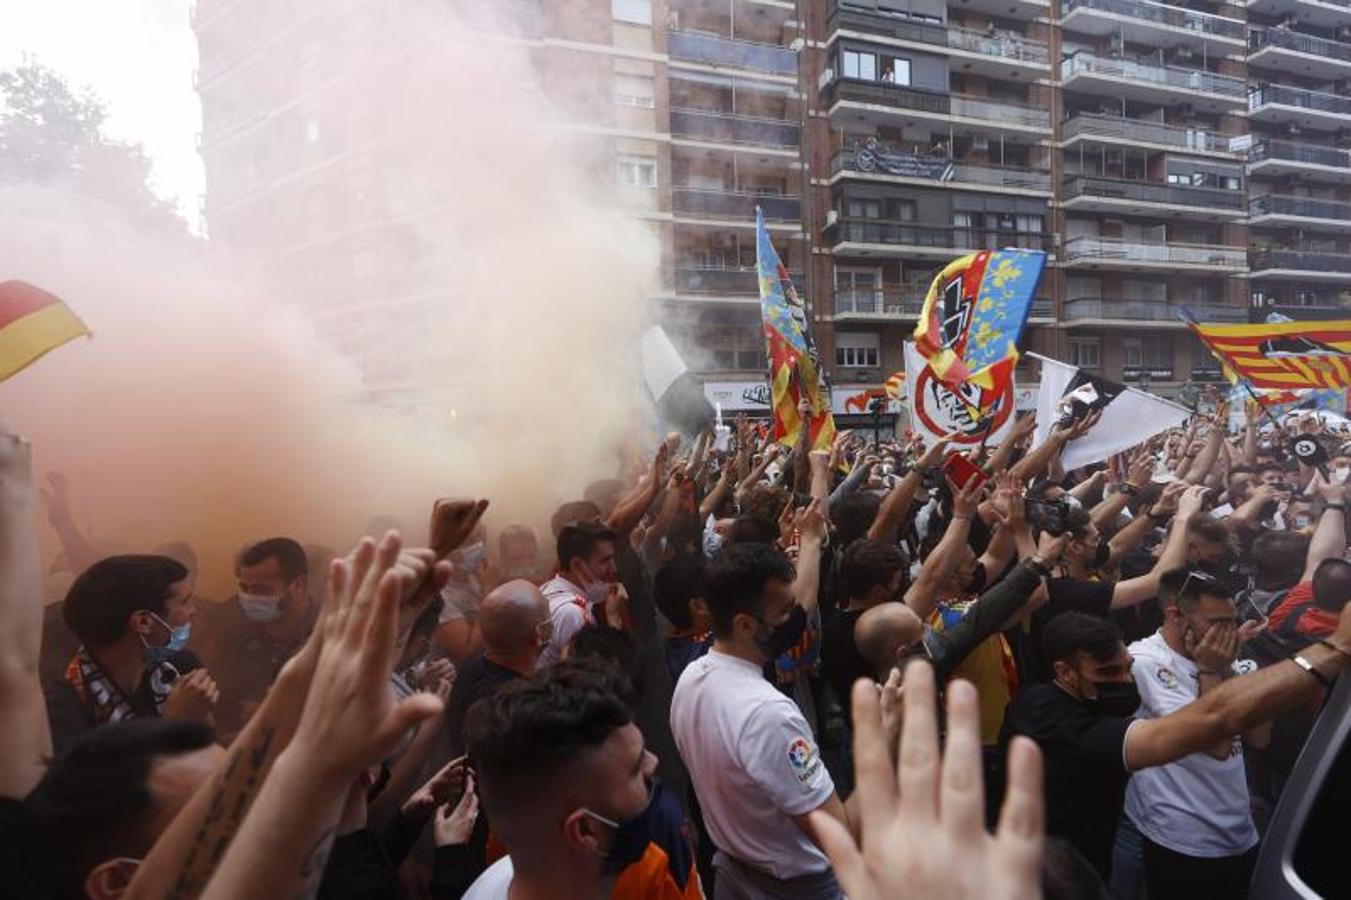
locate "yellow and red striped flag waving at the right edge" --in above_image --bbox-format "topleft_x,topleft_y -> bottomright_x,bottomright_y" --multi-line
1186,319 -> 1351,389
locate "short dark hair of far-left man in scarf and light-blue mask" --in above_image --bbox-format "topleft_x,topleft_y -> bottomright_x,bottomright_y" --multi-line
62,555 -> 188,647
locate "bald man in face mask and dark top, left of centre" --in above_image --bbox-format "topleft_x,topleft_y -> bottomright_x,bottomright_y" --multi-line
446,580 -> 554,757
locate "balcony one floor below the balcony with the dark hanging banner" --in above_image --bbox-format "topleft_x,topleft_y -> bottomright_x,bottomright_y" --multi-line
825,219 -> 1054,261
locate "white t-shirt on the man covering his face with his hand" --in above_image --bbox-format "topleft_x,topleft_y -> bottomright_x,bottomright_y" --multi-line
1125,632 -> 1258,858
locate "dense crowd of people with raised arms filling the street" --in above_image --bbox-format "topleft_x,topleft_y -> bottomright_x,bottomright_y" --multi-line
0,400 -> 1351,900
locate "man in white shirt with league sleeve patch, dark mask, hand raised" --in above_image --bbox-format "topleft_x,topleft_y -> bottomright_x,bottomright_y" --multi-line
671,516 -> 848,900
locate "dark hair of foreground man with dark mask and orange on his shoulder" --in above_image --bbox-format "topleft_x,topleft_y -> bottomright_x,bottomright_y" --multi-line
465,659 -> 634,810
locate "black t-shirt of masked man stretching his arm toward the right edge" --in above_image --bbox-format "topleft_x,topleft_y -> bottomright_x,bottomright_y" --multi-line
1002,684 -> 1135,880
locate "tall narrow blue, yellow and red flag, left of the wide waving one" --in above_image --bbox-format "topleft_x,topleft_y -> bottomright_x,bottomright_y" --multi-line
755,208 -> 835,450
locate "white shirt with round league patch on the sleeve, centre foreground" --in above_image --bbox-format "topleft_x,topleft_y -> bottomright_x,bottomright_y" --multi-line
671,650 -> 835,880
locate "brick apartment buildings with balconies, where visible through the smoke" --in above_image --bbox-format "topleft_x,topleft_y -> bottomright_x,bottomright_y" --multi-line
193,0 -> 1351,408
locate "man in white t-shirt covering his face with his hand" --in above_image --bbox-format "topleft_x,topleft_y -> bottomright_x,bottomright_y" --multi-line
1125,569 -> 1270,900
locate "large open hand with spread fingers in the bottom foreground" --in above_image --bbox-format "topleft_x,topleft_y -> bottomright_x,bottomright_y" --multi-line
811,661 -> 1046,900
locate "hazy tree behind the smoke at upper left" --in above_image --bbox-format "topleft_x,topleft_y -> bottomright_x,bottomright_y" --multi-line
0,61 -> 186,230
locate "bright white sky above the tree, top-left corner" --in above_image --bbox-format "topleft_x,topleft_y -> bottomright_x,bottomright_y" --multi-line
0,0 -> 205,230
